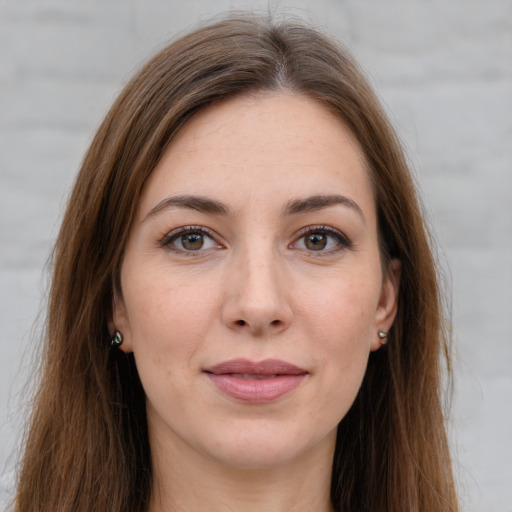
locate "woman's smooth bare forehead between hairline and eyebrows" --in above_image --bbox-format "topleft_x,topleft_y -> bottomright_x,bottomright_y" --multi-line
141,93 -> 373,221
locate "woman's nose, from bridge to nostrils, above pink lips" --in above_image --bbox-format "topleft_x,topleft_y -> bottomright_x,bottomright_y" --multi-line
222,245 -> 293,336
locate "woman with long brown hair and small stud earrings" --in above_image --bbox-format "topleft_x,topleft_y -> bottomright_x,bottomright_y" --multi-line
15,14 -> 458,512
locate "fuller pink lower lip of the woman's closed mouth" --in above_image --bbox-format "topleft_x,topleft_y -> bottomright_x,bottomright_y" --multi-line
207,373 -> 306,404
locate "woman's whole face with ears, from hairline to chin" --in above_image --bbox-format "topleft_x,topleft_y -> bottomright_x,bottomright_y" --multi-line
111,93 -> 397,468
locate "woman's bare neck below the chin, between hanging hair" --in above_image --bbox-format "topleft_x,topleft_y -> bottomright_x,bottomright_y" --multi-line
149,430 -> 333,512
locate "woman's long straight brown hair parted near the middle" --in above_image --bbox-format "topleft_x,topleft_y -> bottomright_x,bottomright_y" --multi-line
15,17 -> 458,512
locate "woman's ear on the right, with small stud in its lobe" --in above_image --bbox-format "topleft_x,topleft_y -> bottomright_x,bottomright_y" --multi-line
370,259 -> 402,351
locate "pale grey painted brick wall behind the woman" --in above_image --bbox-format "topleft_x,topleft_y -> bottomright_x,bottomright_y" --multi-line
0,0 -> 512,512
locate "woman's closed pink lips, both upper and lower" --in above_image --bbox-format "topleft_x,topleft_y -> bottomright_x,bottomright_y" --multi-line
204,359 -> 308,404
